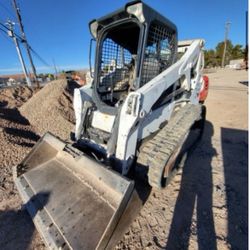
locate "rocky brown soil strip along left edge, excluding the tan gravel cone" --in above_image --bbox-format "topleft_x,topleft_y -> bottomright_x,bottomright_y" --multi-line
0,87 -> 43,249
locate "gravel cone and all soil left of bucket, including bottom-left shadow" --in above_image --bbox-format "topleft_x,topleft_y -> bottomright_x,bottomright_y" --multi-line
0,80 -> 78,249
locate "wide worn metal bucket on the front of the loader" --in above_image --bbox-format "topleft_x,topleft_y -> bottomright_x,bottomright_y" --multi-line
14,133 -> 141,249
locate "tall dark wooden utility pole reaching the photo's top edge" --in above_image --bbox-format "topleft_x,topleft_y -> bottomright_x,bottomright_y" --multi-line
12,0 -> 40,88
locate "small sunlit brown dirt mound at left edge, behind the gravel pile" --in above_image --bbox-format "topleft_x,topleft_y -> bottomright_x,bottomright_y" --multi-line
0,86 -> 37,108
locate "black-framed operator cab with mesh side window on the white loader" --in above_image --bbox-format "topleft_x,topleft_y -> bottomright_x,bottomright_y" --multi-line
90,1 -> 177,114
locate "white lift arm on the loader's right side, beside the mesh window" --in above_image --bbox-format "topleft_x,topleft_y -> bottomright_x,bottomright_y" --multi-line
116,40 -> 204,164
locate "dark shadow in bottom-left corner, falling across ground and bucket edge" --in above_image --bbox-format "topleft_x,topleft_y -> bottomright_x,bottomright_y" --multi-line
0,192 -> 50,250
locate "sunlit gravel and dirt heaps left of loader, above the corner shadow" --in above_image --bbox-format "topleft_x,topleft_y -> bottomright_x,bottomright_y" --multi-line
0,80 -> 78,191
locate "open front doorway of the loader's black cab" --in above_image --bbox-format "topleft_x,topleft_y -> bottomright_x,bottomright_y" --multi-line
96,21 -> 140,107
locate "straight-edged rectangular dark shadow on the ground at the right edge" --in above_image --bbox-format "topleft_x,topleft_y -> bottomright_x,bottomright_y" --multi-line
221,128 -> 248,250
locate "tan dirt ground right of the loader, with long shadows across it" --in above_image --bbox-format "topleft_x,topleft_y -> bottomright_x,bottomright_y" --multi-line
117,70 -> 248,250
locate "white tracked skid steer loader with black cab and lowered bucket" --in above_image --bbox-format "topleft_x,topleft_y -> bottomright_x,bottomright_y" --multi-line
14,1 -> 205,249
